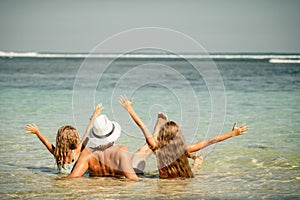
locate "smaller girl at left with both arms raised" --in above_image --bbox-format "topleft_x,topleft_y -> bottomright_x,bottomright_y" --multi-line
25,104 -> 102,174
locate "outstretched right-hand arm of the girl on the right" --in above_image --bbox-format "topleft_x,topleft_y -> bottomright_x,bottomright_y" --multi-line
187,123 -> 249,153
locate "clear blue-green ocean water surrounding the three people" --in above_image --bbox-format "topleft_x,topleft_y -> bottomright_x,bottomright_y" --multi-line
0,52 -> 300,199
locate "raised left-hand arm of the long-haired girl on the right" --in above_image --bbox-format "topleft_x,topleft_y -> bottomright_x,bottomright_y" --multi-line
119,96 -> 156,148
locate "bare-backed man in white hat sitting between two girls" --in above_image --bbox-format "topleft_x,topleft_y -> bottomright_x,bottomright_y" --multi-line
67,115 -> 139,180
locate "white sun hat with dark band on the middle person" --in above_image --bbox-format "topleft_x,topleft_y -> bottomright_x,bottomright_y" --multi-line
89,115 -> 121,146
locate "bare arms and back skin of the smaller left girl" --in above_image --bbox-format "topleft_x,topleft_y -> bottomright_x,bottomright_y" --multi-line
25,103 -> 102,164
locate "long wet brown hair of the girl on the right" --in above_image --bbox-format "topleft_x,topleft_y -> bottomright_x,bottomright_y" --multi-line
155,121 -> 194,178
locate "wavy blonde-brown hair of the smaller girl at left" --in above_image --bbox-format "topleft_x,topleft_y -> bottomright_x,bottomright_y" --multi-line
53,126 -> 80,167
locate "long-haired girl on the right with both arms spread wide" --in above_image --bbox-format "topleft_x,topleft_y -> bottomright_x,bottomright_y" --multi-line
120,96 -> 249,178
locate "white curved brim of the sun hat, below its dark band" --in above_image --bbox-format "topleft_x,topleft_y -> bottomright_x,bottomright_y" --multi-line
89,121 -> 121,146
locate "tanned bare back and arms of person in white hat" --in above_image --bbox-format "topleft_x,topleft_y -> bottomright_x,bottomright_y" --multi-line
67,146 -> 139,180
